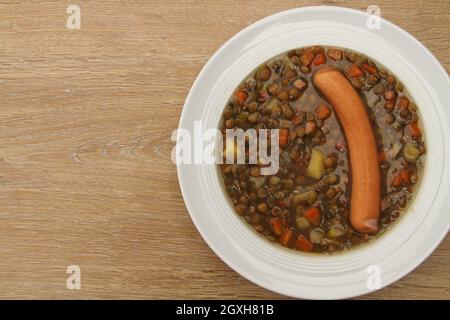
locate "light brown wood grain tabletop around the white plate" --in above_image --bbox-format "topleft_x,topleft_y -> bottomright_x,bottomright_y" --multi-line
0,0 -> 450,299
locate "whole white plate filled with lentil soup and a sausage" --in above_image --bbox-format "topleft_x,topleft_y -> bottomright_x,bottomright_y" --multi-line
178,7 -> 449,298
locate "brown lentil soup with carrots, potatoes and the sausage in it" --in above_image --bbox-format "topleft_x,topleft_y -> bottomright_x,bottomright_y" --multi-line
220,46 -> 425,254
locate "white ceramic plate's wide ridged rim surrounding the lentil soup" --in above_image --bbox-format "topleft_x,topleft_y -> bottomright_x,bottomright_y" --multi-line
178,7 -> 450,299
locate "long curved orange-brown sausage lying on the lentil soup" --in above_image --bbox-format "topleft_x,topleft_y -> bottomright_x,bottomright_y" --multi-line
313,67 -> 381,233
